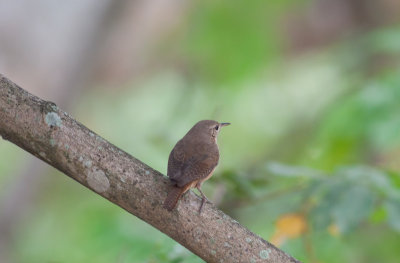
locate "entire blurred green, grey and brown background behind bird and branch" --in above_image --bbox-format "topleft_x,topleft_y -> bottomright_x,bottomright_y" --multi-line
0,0 -> 400,263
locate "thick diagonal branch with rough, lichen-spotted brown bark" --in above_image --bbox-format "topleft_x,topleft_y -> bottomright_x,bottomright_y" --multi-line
0,74 -> 299,263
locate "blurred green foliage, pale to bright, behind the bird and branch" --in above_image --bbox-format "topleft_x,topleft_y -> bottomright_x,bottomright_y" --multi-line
0,0 -> 400,263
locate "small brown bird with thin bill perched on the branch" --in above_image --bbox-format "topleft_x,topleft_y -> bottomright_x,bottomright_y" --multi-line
164,120 -> 230,213
